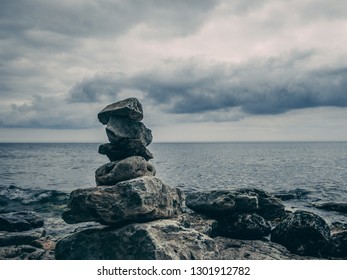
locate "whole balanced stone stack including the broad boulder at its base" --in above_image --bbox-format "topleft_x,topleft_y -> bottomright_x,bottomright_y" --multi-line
55,98 -> 216,259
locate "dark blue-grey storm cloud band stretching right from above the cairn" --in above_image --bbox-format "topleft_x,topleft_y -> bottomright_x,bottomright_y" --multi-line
143,54 -> 347,115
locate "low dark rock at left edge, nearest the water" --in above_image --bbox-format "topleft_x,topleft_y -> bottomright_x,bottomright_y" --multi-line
0,211 -> 43,231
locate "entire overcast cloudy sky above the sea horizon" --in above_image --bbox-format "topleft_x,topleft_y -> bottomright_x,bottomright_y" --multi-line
0,0 -> 347,142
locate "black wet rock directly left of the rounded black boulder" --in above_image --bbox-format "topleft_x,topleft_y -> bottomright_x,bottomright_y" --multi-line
217,213 -> 271,239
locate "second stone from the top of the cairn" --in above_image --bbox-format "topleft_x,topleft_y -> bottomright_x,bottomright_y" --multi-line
106,117 -> 153,149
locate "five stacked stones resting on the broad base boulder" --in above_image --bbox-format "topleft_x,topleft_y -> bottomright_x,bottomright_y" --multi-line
58,98 -> 185,226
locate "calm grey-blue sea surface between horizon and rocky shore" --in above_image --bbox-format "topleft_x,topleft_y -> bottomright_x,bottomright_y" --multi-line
0,142 -> 347,223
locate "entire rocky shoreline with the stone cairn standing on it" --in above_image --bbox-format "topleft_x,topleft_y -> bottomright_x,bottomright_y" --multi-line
0,98 -> 347,260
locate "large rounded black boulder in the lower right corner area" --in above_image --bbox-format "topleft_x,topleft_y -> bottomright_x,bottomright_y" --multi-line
271,211 -> 330,256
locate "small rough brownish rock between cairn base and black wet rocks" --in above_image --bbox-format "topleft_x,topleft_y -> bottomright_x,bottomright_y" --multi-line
177,212 -> 218,237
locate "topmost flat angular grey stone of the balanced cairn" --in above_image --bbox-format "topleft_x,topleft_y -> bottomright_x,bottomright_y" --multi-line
98,97 -> 143,124
